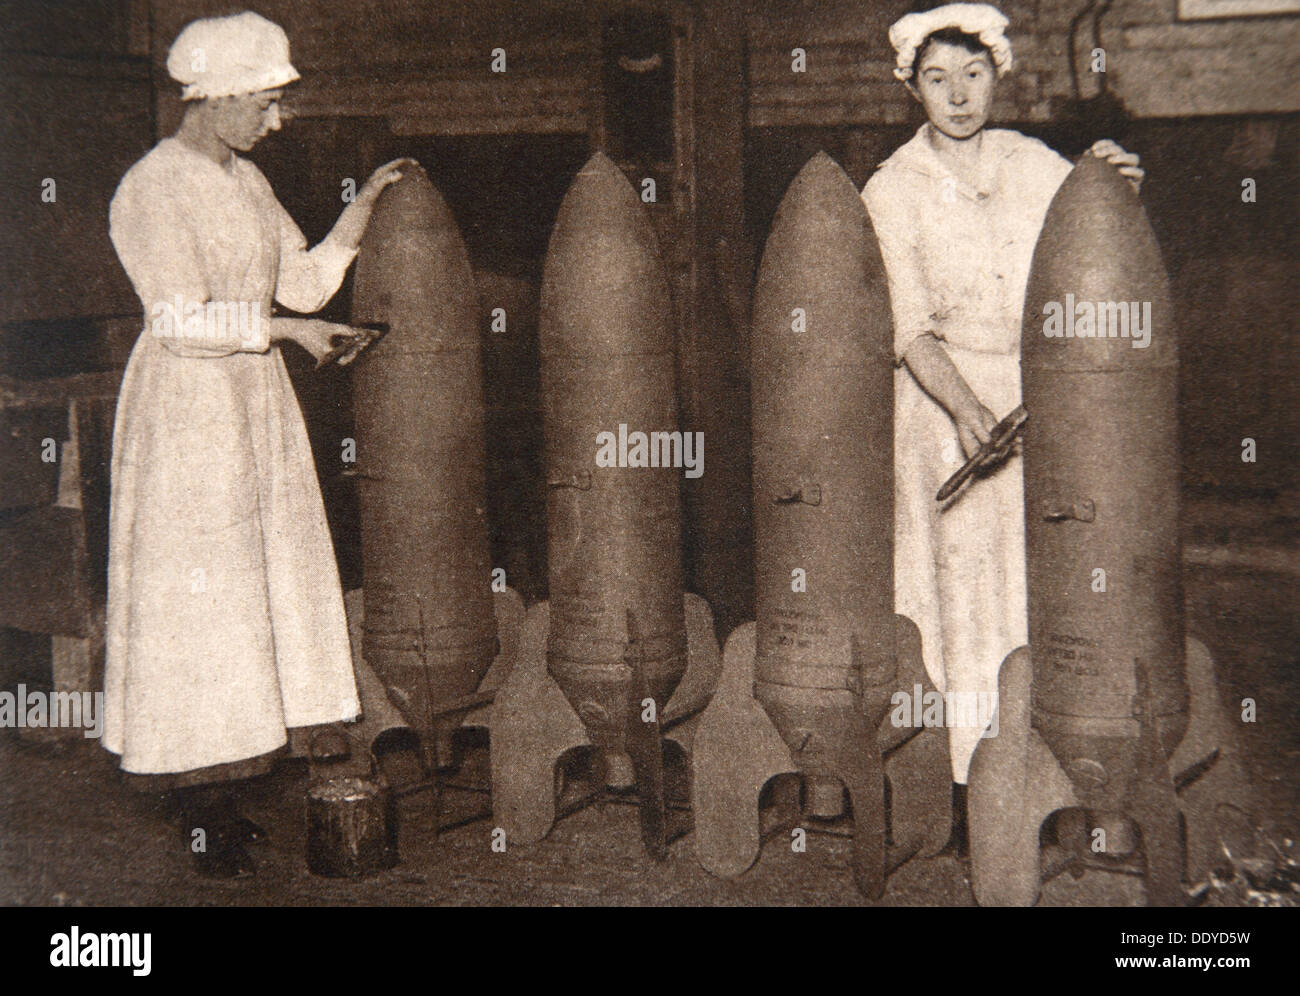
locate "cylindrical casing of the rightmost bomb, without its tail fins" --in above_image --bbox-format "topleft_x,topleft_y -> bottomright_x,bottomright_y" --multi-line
1022,156 -> 1188,806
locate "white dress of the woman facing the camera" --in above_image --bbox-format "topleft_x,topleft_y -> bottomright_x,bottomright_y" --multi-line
862,124 -> 1070,784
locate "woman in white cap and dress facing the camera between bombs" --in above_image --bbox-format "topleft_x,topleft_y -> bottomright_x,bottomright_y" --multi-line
862,4 -> 1143,853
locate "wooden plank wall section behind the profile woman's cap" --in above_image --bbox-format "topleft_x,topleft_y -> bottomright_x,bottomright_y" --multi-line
153,0 -> 592,135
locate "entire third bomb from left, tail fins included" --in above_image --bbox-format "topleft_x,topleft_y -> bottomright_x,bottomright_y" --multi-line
693,153 -> 950,896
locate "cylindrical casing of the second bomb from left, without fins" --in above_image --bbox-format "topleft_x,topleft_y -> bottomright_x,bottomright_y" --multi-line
540,152 -> 686,785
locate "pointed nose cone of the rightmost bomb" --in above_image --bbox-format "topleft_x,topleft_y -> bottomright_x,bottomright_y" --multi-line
1021,155 -> 1178,371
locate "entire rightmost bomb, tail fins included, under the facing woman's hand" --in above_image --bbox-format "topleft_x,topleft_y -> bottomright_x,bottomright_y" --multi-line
970,155 -> 1244,905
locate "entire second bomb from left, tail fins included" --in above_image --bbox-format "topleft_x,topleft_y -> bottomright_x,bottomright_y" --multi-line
491,152 -> 718,857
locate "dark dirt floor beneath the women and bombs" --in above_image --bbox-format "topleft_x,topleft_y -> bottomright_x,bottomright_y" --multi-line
0,496 -> 1300,906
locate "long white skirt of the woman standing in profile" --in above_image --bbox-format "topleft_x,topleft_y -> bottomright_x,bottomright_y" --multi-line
104,333 -> 360,774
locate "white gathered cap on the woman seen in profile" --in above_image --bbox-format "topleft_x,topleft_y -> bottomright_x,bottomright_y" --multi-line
166,10 -> 298,100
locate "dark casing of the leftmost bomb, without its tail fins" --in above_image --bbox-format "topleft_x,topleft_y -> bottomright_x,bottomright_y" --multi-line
352,165 -> 521,768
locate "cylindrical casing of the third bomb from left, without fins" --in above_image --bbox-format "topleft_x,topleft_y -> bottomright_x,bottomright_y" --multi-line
751,153 -> 896,815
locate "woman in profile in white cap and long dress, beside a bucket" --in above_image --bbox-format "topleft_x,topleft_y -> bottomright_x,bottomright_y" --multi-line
104,13 -> 402,876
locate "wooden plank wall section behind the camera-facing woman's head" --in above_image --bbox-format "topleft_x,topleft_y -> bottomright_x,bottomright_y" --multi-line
748,0 -> 1300,127
